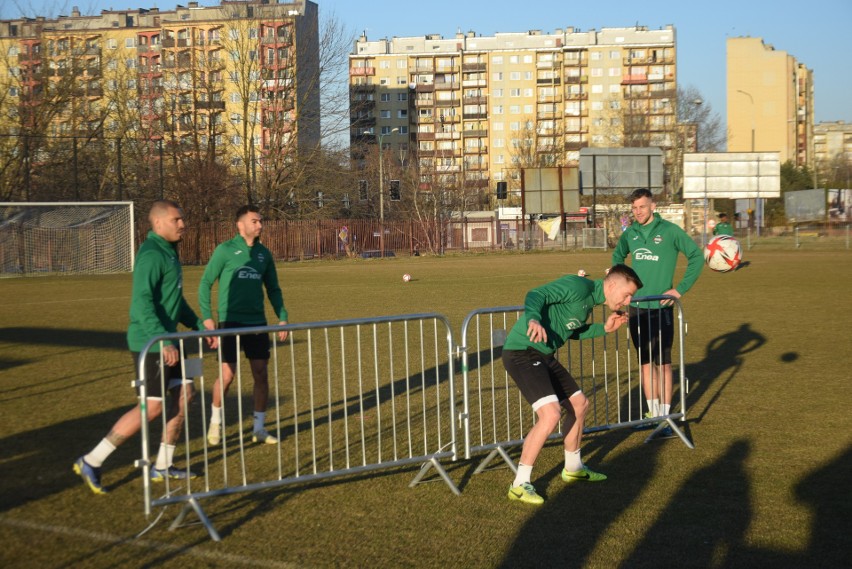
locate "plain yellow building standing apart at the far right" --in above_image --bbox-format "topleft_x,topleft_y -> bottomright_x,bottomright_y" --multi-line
727,37 -> 814,167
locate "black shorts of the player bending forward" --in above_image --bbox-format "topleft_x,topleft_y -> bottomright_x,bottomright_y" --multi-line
503,348 -> 580,410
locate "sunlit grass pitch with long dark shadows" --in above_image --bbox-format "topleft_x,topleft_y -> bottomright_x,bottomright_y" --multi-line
0,247 -> 852,568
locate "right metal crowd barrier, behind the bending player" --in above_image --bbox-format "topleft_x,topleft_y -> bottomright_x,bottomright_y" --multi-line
458,296 -> 694,473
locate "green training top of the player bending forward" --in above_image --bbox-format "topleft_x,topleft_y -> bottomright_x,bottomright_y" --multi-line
503,275 -> 606,354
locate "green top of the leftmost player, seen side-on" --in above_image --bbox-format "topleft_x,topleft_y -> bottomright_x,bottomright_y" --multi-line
127,231 -> 204,352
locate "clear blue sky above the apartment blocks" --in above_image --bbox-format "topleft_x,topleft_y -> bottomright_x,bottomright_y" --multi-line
0,0 -> 852,123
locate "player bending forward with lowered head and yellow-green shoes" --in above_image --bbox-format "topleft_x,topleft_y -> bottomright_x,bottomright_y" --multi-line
503,265 -> 642,504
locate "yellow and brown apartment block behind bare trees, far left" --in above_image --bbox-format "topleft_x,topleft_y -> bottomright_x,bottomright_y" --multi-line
0,0 -> 320,165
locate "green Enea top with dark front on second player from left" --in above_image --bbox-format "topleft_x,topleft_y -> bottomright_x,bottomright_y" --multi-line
198,235 -> 287,325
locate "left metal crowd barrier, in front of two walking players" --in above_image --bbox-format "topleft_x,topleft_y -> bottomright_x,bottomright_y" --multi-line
137,313 -> 459,541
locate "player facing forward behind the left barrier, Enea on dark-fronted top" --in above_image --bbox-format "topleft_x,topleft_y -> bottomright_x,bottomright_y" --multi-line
198,205 -> 287,445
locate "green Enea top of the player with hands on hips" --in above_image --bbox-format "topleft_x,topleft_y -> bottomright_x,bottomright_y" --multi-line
612,213 -> 704,307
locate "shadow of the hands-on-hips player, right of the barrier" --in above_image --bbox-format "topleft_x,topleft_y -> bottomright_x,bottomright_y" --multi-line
675,322 -> 766,423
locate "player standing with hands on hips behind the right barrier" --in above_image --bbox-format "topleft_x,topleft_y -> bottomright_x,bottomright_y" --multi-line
612,188 -> 704,435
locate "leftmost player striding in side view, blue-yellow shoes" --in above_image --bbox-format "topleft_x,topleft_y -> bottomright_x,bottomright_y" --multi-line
74,200 -> 216,494
